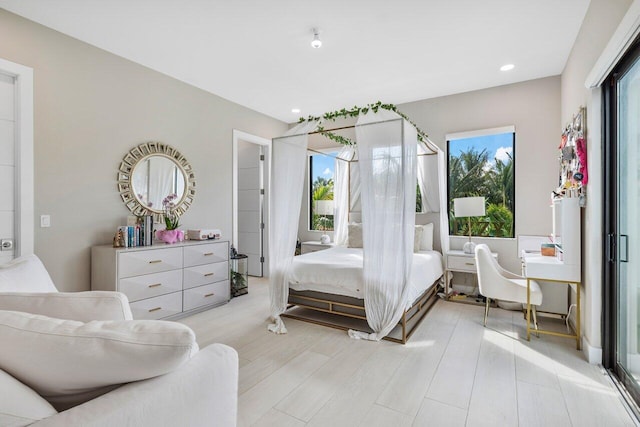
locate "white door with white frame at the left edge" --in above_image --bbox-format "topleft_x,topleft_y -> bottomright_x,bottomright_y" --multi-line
0,59 -> 34,264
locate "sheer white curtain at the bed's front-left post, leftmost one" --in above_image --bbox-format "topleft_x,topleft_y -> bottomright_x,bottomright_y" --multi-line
268,122 -> 318,334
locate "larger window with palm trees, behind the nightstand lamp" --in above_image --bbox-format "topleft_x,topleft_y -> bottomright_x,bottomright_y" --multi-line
447,126 -> 515,237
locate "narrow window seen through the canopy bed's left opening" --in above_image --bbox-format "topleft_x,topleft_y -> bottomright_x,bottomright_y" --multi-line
309,152 -> 339,231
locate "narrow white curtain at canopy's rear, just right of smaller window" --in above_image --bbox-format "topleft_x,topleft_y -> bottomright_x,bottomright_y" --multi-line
333,145 -> 355,245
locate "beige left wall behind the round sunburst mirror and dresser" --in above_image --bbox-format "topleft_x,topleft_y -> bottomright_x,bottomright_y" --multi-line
0,9 -> 287,291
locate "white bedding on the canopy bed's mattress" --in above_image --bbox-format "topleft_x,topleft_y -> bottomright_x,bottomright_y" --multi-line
289,246 -> 444,307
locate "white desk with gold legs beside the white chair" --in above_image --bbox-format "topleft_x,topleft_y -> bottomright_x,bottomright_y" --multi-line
524,255 -> 581,350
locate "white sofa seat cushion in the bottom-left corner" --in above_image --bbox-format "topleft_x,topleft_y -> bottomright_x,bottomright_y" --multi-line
0,370 -> 58,427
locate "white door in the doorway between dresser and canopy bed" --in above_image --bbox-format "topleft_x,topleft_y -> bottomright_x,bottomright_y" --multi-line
236,141 -> 264,277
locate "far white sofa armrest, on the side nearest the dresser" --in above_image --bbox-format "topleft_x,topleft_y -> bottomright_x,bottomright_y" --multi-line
0,291 -> 133,322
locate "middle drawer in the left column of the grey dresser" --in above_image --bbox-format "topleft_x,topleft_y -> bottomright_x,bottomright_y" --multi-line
118,270 -> 182,301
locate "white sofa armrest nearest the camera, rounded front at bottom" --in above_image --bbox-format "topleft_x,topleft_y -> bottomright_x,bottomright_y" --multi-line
33,344 -> 238,427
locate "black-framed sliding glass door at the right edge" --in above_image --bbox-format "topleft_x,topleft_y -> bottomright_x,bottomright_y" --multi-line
605,38 -> 640,401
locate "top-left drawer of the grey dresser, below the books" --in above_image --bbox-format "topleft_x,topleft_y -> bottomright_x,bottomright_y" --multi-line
118,248 -> 182,278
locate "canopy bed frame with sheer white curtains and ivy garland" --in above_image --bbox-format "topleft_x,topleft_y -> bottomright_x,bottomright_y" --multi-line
269,103 -> 448,343
